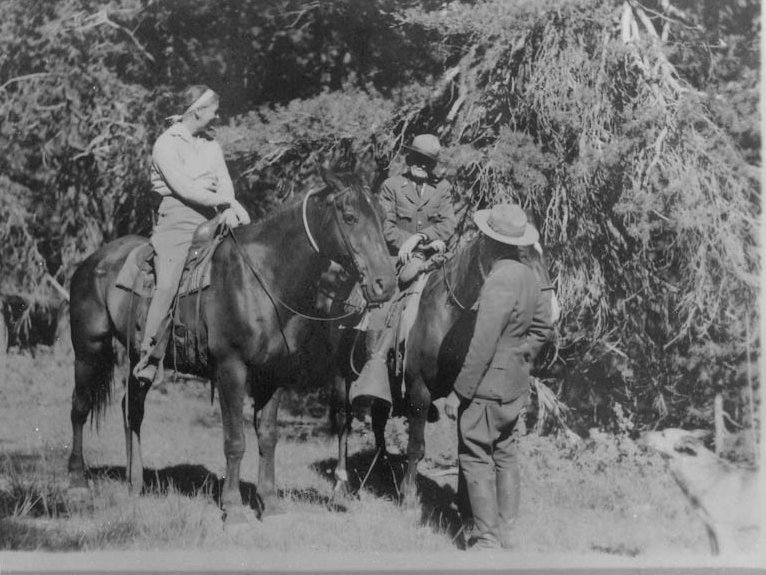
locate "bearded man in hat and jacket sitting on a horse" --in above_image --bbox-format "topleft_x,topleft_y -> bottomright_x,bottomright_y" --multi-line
349,134 -> 456,415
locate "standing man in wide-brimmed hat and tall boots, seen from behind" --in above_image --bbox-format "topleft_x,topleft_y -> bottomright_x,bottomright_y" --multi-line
444,204 -> 553,550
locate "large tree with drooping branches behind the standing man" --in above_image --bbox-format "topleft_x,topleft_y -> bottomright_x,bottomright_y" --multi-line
402,2 -> 760,434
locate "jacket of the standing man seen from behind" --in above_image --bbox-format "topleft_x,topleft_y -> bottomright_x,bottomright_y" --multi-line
454,259 -> 553,403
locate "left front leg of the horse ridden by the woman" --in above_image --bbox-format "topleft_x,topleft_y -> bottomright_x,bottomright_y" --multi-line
215,359 -> 249,525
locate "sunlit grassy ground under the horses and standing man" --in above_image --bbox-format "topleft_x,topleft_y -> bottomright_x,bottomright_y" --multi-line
0,344 -> 736,556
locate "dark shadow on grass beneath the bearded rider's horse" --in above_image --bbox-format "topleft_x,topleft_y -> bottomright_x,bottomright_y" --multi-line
312,449 -> 464,546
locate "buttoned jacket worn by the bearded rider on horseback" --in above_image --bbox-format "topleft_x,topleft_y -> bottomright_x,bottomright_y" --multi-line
380,175 -> 456,255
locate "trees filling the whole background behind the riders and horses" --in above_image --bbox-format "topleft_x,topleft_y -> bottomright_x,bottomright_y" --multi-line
0,0 -> 761,450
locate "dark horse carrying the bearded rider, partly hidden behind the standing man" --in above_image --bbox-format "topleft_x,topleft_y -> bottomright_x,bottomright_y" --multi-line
326,234 -> 558,501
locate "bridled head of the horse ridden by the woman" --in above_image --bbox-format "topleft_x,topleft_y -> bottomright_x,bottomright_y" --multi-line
313,171 -> 396,302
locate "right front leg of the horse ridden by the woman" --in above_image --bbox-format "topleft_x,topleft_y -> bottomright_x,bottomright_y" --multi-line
255,387 -> 284,516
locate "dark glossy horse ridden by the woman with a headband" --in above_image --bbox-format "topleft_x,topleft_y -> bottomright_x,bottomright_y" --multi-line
69,173 -> 395,522
